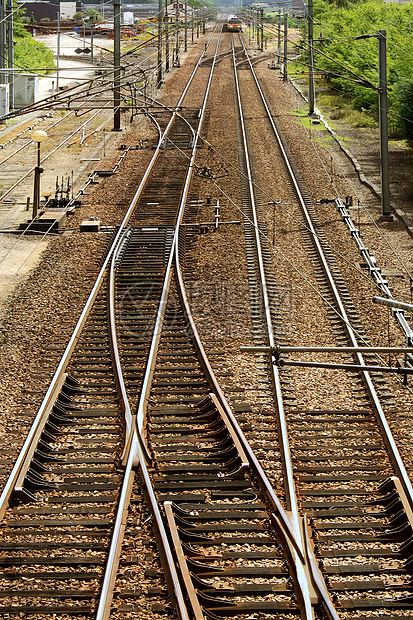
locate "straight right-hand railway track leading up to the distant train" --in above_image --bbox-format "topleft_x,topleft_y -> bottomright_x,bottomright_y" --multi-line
234,27 -> 412,618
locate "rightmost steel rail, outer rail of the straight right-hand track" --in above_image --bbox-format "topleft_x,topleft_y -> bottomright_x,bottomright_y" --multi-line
237,32 -> 413,508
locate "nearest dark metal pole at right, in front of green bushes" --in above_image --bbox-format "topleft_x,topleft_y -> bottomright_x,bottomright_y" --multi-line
377,30 -> 393,221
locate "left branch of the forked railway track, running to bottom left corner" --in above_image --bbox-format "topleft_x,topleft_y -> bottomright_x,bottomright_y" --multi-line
0,23 -> 217,617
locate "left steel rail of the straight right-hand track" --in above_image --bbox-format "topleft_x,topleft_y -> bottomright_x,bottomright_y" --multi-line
231,35 -> 314,620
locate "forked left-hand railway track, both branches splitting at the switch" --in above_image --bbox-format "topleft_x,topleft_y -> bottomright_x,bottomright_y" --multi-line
0,20 -> 318,618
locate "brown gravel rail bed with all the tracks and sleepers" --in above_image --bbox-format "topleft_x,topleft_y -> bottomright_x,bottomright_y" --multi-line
0,13 -> 413,620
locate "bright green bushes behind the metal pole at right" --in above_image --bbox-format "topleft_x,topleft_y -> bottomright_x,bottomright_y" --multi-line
300,0 -> 413,137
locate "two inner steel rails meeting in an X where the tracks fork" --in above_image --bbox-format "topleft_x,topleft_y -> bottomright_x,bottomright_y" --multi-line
96,26 -> 218,620
